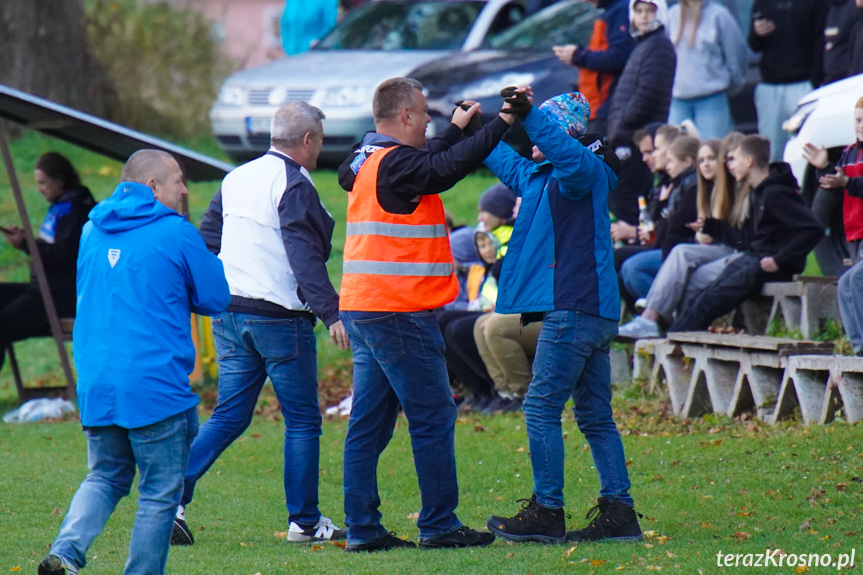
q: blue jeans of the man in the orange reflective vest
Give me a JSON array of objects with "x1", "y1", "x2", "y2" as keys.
[{"x1": 340, "y1": 311, "x2": 461, "y2": 545}]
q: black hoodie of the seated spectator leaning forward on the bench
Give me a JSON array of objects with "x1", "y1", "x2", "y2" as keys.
[{"x1": 704, "y1": 162, "x2": 824, "y2": 277}]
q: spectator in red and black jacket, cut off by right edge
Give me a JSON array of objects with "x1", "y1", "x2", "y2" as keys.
[{"x1": 803, "y1": 98, "x2": 863, "y2": 355}]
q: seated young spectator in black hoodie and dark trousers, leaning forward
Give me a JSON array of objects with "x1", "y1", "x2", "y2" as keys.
[{"x1": 668, "y1": 136, "x2": 824, "y2": 331}]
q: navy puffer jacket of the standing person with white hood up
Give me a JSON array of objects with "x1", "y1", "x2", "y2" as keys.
[{"x1": 608, "y1": 26, "x2": 677, "y2": 146}]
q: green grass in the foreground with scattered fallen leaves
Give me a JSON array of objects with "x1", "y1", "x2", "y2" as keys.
[{"x1": 0, "y1": 398, "x2": 863, "y2": 575}]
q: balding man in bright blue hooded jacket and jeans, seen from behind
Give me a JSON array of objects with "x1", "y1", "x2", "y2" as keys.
[{"x1": 38, "y1": 150, "x2": 230, "y2": 575}]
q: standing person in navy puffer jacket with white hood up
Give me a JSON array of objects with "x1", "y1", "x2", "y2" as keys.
[{"x1": 608, "y1": 0, "x2": 677, "y2": 234}]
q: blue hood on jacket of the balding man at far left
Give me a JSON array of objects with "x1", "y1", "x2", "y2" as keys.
[{"x1": 90, "y1": 182, "x2": 179, "y2": 234}]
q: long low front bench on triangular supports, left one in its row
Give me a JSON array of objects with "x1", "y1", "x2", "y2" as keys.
[{"x1": 633, "y1": 332, "x2": 833, "y2": 423}]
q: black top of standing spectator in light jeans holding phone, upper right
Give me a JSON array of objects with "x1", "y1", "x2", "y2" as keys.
[{"x1": 749, "y1": 0, "x2": 827, "y2": 86}]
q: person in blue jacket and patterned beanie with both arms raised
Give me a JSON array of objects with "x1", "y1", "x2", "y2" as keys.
[{"x1": 485, "y1": 86, "x2": 641, "y2": 543}]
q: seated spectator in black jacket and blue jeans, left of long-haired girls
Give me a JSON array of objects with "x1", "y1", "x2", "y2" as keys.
[{"x1": 620, "y1": 136, "x2": 699, "y2": 300}]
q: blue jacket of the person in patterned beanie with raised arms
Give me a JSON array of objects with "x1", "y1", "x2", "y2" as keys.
[{"x1": 485, "y1": 108, "x2": 620, "y2": 321}]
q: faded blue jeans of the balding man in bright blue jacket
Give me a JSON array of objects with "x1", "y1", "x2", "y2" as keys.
[{"x1": 51, "y1": 407, "x2": 198, "y2": 575}]
